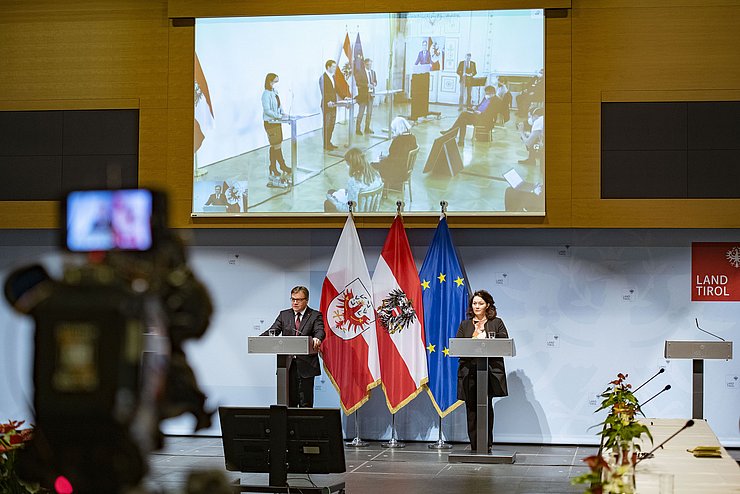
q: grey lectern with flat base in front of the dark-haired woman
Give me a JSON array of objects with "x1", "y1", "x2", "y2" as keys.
[{"x1": 448, "y1": 338, "x2": 516, "y2": 463}]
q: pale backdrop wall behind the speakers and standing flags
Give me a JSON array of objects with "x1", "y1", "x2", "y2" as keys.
[{"x1": 0, "y1": 229, "x2": 740, "y2": 446}]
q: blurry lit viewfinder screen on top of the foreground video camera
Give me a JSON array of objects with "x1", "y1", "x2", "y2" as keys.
[{"x1": 66, "y1": 189, "x2": 152, "y2": 252}]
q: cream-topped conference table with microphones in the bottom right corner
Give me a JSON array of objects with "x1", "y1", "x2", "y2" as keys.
[{"x1": 635, "y1": 419, "x2": 740, "y2": 494}]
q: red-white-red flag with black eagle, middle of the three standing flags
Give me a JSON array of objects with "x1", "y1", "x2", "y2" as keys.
[{"x1": 373, "y1": 215, "x2": 428, "y2": 413}]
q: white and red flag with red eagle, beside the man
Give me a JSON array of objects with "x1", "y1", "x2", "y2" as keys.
[{"x1": 321, "y1": 215, "x2": 380, "y2": 415}]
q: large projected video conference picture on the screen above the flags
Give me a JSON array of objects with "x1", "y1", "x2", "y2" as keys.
[{"x1": 193, "y1": 10, "x2": 545, "y2": 216}]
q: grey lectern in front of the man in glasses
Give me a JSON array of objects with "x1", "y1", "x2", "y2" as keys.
[{"x1": 247, "y1": 336, "x2": 316, "y2": 406}]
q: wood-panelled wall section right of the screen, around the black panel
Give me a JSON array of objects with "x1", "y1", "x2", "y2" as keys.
[{"x1": 571, "y1": 0, "x2": 740, "y2": 228}]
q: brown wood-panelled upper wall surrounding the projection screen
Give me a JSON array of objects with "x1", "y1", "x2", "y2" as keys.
[{"x1": 0, "y1": 0, "x2": 740, "y2": 228}]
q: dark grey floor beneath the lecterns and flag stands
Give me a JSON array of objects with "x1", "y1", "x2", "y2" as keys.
[{"x1": 146, "y1": 437, "x2": 596, "y2": 494}]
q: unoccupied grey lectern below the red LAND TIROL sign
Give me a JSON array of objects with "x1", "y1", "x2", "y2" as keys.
[{"x1": 664, "y1": 340, "x2": 732, "y2": 419}]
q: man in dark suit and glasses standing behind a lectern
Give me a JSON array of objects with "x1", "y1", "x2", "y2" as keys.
[{"x1": 262, "y1": 286, "x2": 326, "y2": 408}]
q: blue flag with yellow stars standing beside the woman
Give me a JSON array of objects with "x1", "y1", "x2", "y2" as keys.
[{"x1": 419, "y1": 217, "x2": 468, "y2": 417}]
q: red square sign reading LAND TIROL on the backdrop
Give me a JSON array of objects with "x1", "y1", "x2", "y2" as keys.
[{"x1": 691, "y1": 242, "x2": 740, "y2": 302}]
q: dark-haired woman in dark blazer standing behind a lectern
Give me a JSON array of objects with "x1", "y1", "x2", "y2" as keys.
[{"x1": 456, "y1": 290, "x2": 509, "y2": 451}]
